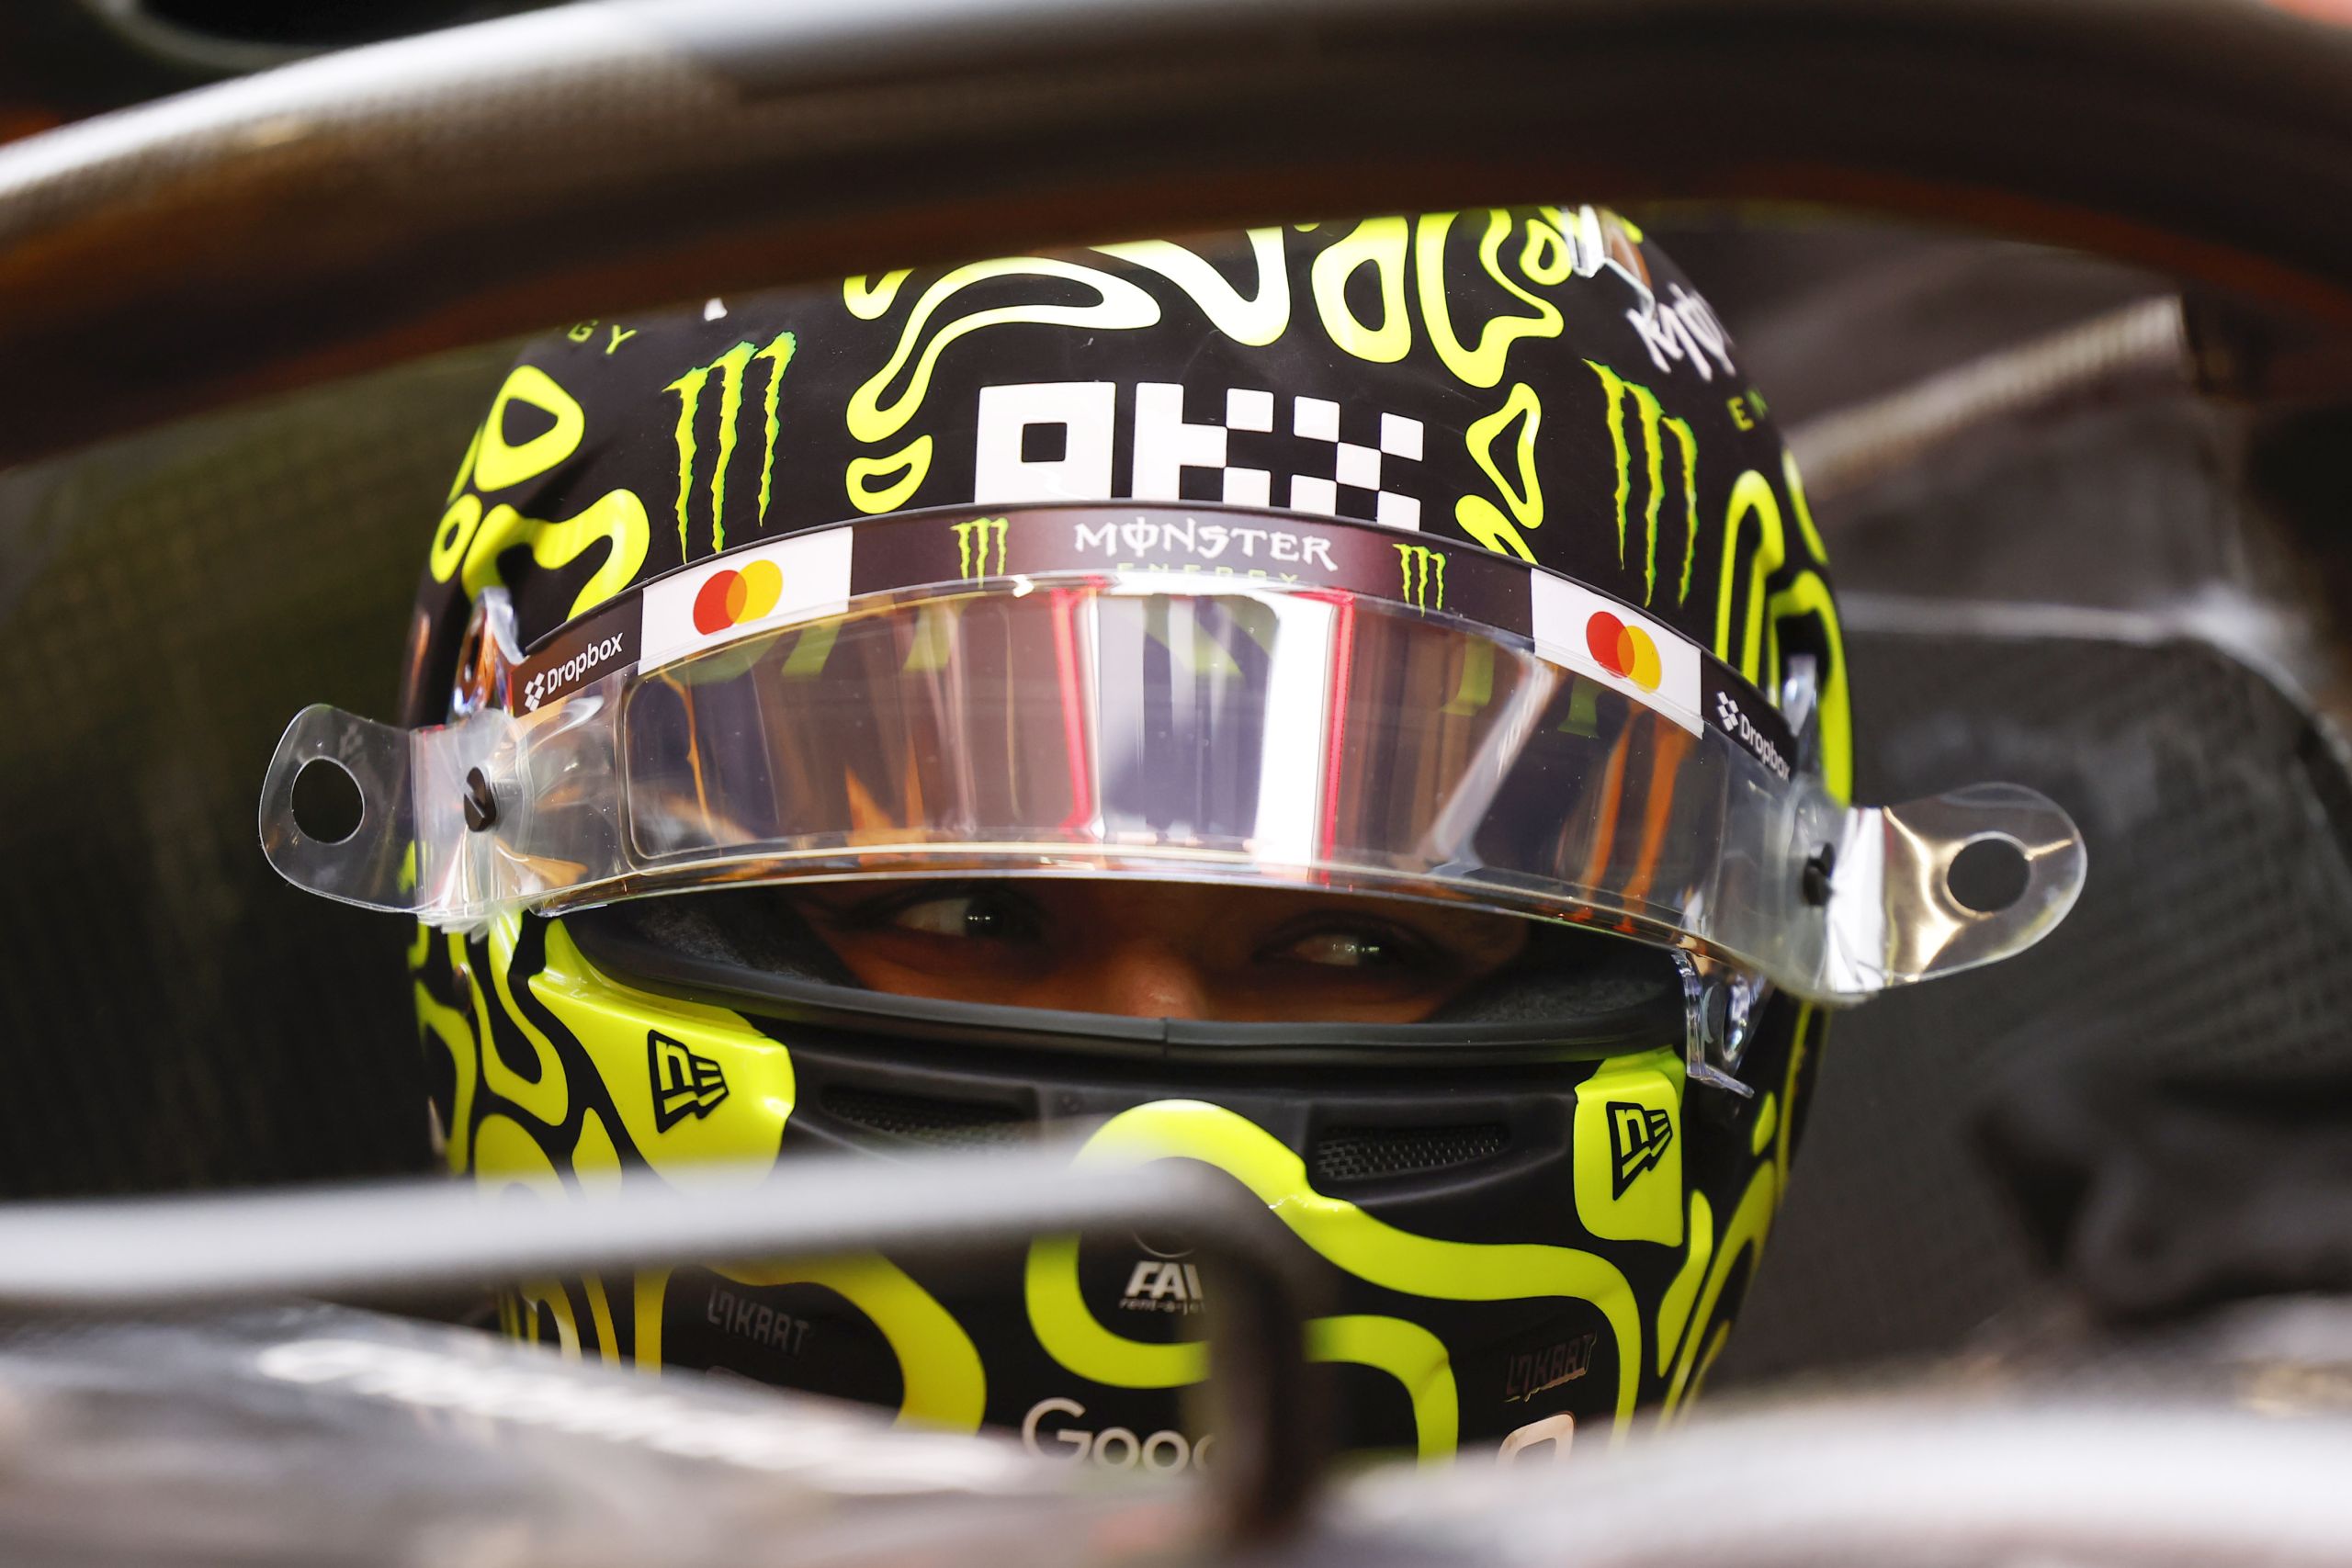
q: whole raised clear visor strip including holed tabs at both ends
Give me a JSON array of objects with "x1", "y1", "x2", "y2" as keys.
[{"x1": 264, "y1": 505, "x2": 2082, "y2": 999}]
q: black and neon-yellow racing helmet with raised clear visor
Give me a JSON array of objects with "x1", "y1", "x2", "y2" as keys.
[{"x1": 261, "y1": 207, "x2": 2084, "y2": 1470}]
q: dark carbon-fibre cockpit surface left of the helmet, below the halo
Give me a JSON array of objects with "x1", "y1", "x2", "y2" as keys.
[{"x1": 0, "y1": 350, "x2": 505, "y2": 1197}]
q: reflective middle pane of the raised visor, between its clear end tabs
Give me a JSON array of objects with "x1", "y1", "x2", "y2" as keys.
[{"x1": 618, "y1": 588, "x2": 1721, "y2": 917}]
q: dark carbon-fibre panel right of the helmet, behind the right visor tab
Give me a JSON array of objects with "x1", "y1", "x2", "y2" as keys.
[{"x1": 1713, "y1": 632, "x2": 2352, "y2": 1389}]
